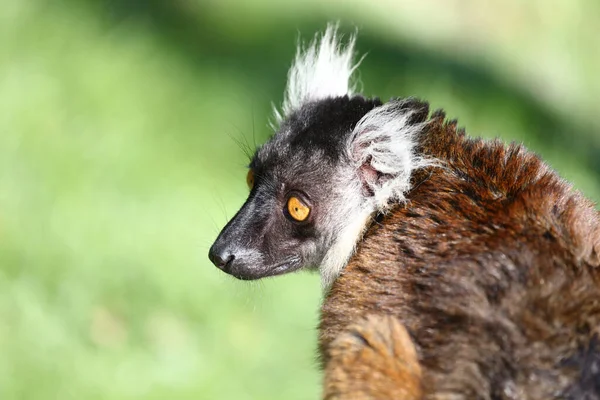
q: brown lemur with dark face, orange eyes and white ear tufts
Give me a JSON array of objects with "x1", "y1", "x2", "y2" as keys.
[{"x1": 209, "y1": 25, "x2": 600, "y2": 400}]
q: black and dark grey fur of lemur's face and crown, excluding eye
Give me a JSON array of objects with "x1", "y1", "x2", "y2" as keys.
[{"x1": 209, "y1": 96, "x2": 382, "y2": 279}]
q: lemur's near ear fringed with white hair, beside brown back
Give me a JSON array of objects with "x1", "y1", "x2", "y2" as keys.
[{"x1": 349, "y1": 99, "x2": 433, "y2": 210}]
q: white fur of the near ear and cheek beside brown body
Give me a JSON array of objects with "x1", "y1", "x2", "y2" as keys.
[{"x1": 320, "y1": 101, "x2": 437, "y2": 290}]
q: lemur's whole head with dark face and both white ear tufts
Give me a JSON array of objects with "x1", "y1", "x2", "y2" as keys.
[{"x1": 209, "y1": 26, "x2": 430, "y2": 287}]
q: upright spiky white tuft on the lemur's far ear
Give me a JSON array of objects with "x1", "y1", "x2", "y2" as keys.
[{"x1": 274, "y1": 24, "x2": 360, "y2": 124}]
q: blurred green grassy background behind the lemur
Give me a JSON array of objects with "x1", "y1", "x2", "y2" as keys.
[{"x1": 0, "y1": 0, "x2": 600, "y2": 400}]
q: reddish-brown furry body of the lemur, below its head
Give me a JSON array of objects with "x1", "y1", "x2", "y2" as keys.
[{"x1": 320, "y1": 106, "x2": 600, "y2": 399}]
